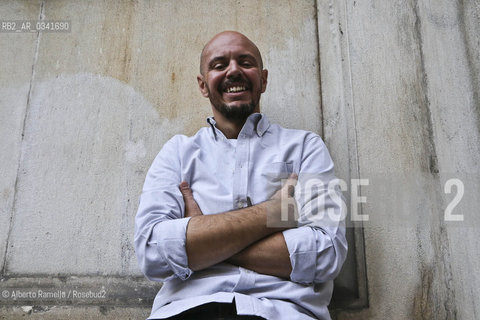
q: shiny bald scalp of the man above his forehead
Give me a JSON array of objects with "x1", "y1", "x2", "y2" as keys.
[{"x1": 200, "y1": 31, "x2": 263, "y2": 75}]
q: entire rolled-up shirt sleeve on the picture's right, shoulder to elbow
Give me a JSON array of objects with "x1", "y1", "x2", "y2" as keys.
[{"x1": 283, "y1": 135, "x2": 347, "y2": 284}]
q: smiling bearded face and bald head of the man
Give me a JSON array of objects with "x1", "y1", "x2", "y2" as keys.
[{"x1": 197, "y1": 31, "x2": 268, "y2": 121}]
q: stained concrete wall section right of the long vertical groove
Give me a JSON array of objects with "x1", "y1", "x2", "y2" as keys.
[{"x1": 318, "y1": 0, "x2": 480, "y2": 319}]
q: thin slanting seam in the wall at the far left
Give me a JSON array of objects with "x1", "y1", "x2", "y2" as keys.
[{"x1": 1, "y1": 1, "x2": 45, "y2": 277}]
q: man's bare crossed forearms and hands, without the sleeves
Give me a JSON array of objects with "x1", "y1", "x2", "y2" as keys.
[{"x1": 179, "y1": 175, "x2": 297, "y2": 279}]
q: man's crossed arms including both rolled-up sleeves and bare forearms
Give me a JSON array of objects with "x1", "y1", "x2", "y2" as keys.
[{"x1": 135, "y1": 137, "x2": 347, "y2": 284}]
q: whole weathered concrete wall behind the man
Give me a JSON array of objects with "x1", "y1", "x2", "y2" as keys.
[{"x1": 0, "y1": 0, "x2": 480, "y2": 319}]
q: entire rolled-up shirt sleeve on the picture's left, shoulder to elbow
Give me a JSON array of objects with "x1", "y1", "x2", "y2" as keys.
[{"x1": 135, "y1": 136, "x2": 192, "y2": 281}]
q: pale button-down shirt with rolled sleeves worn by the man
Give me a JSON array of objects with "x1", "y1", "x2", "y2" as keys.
[{"x1": 135, "y1": 113, "x2": 347, "y2": 320}]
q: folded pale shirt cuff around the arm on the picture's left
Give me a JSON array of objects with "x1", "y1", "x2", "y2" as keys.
[{"x1": 151, "y1": 218, "x2": 193, "y2": 280}]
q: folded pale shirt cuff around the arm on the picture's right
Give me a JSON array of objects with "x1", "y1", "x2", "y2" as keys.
[{"x1": 283, "y1": 227, "x2": 317, "y2": 284}]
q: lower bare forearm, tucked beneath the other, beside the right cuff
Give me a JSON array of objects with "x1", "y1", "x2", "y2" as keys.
[{"x1": 227, "y1": 232, "x2": 292, "y2": 279}]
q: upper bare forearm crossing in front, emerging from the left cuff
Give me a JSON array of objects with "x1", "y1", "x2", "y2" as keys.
[{"x1": 186, "y1": 201, "x2": 281, "y2": 270}]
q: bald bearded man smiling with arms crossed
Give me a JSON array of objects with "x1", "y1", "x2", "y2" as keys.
[{"x1": 135, "y1": 31, "x2": 347, "y2": 320}]
